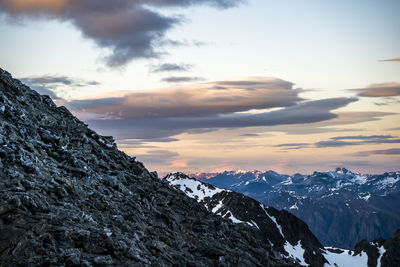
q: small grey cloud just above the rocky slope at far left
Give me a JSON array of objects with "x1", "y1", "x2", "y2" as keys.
[{"x1": 20, "y1": 75, "x2": 100, "y2": 100}]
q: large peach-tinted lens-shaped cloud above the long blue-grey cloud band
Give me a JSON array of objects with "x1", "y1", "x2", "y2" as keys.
[{"x1": 69, "y1": 78, "x2": 304, "y2": 119}]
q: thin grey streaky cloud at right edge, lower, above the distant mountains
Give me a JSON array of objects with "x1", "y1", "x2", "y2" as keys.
[{"x1": 315, "y1": 135, "x2": 400, "y2": 148}]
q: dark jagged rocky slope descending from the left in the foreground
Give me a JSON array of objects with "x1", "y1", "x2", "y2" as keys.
[{"x1": 0, "y1": 69, "x2": 297, "y2": 266}]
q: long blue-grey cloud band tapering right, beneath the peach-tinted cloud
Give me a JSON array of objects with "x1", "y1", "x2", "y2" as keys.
[{"x1": 79, "y1": 98, "x2": 356, "y2": 139}]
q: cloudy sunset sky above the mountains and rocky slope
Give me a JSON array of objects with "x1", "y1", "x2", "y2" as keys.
[{"x1": 0, "y1": 0, "x2": 400, "y2": 175}]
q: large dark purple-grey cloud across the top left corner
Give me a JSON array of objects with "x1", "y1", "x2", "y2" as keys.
[{"x1": 0, "y1": 0, "x2": 242, "y2": 67}]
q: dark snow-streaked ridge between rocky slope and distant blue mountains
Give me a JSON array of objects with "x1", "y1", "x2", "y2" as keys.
[{"x1": 165, "y1": 173, "x2": 400, "y2": 267}]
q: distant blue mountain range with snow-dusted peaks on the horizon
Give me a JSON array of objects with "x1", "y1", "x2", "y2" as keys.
[{"x1": 191, "y1": 168, "x2": 400, "y2": 249}]
